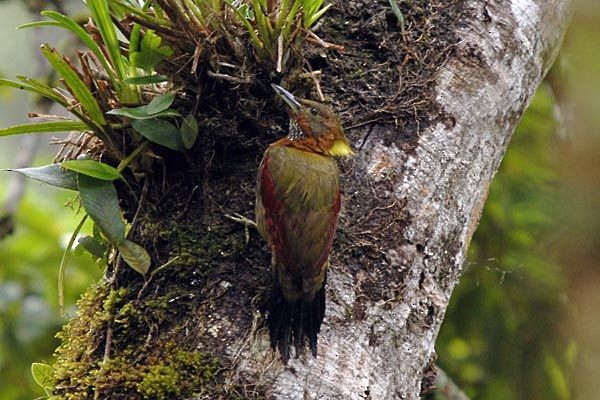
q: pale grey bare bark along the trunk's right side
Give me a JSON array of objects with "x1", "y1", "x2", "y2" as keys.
[{"x1": 230, "y1": 0, "x2": 569, "y2": 400}]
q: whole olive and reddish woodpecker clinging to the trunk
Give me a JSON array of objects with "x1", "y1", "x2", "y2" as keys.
[{"x1": 256, "y1": 85, "x2": 352, "y2": 362}]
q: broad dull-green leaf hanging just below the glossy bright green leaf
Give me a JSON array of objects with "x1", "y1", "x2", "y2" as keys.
[{"x1": 77, "y1": 174, "x2": 125, "y2": 245}]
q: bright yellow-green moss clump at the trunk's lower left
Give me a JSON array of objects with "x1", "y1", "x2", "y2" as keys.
[{"x1": 54, "y1": 285, "x2": 218, "y2": 400}]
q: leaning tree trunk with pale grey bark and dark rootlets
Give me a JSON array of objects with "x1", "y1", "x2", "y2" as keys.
[{"x1": 52, "y1": 0, "x2": 569, "y2": 400}]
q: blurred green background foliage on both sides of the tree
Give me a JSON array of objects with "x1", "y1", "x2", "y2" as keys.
[{"x1": 0, "y1": 1, "x2": 600, "y2": 400}]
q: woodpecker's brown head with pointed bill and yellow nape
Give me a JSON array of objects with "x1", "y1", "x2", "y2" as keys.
[{"x1": 271, "y1": 84, "x2": 354, "y2": 156}]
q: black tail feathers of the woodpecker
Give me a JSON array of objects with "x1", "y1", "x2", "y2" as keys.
[{"x1": 267, "y1": 280, "x2": 325, "y2": 363}]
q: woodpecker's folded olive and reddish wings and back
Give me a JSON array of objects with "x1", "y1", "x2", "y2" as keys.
[{"x1": 257, "y1": 147, "x2": 340, "y2": 291}]
